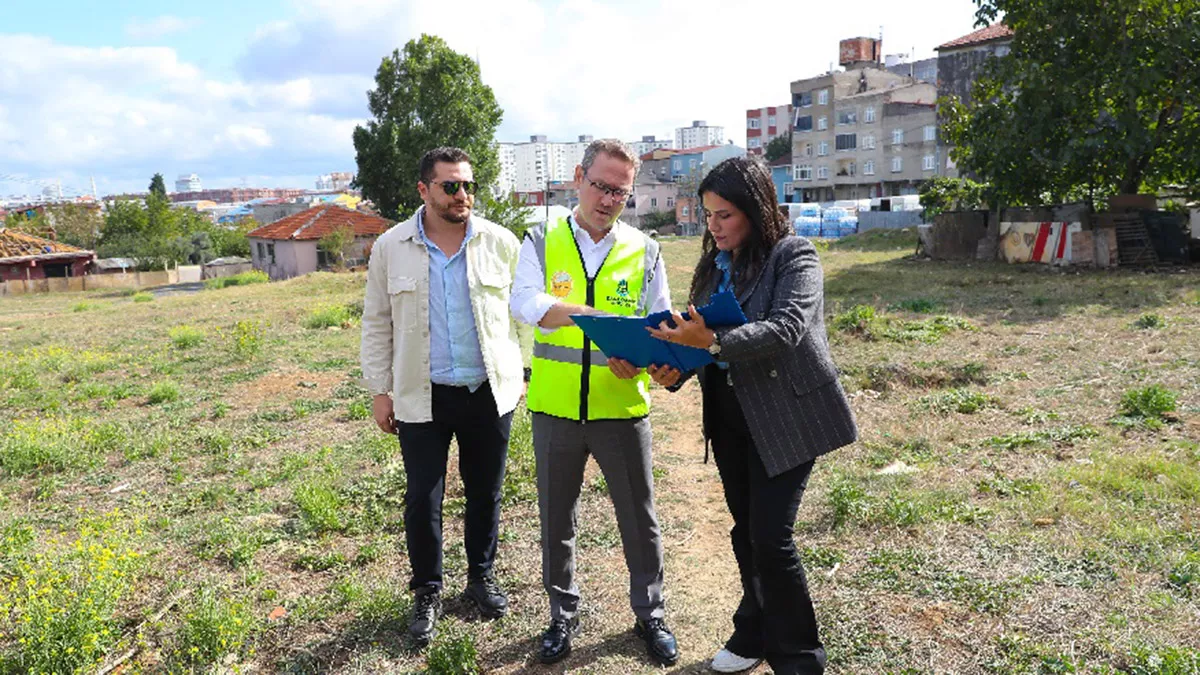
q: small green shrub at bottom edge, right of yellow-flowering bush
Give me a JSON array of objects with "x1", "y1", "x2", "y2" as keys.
[{"x1": 172, "y1": 589, "x2": 259, "y2": 671}]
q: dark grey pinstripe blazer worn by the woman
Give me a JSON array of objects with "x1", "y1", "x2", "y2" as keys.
[{"x1": 697, "y1": 237, "x2": 858, "y2": 477}]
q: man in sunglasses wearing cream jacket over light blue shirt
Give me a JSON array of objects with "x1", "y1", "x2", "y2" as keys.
[{"x1": 361, "y1": 148, "x2": 524, "y2": 647}]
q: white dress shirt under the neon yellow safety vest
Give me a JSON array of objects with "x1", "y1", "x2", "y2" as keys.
[{"x1": 509, "y1": 214, "x2": 671, "y2": 333}]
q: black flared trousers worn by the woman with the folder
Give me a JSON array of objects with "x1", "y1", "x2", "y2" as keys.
[{"x1": 704, "y1": 365, "x2": 826, "y2": 675}]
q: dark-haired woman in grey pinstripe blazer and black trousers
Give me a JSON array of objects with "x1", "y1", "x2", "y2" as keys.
[{"x1": 649, "y1": 157, "x2": 858, "y2": 675}]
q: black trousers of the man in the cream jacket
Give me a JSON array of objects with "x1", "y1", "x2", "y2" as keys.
[{"x1": 398, "y1": 382, "x2": 512, "y2": 591}]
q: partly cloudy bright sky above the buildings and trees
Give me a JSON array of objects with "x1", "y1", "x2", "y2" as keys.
[{"x1": 0, "y1": 0, "x2": 976, "y2": 199}]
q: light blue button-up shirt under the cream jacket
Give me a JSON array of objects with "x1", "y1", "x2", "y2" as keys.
[{"x1": 416, "y1": 209, "x2": 487, "y2": 392}]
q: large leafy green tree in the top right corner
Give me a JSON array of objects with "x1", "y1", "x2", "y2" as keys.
[{"x1": 941, "y1": 0, "x2": 1200, "y2": 204}]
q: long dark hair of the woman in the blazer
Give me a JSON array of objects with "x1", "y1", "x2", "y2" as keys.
[{"x1": 690, "y1": 157, "x2": 792, "y2": 303}]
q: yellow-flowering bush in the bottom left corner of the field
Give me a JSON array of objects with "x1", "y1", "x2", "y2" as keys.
[{"x1": 0, "y1": 512, "x2": 140, "y2": 673}]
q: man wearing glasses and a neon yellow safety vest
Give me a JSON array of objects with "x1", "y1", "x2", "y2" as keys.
[{"x1": 510, "y1": 139, "x2": 679, "y2": 665}]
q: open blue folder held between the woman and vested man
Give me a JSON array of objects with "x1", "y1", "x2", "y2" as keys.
[{"x1": 571, "y1": 292, "x2": 746, "y2": 372}]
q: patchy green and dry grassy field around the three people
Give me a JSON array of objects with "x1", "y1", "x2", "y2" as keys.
[{"x1": 0, "y1": 228, "x2": 1200, "y2": 675}]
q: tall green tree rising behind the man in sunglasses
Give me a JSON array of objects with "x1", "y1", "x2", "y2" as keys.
[{"x1": 354, "y1": 35, "x2": 504, "y2": 220}]
